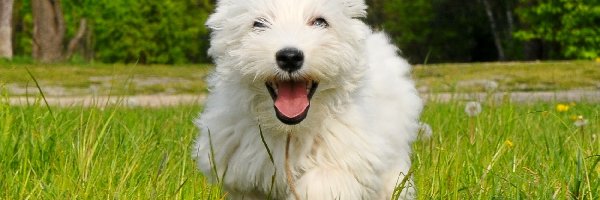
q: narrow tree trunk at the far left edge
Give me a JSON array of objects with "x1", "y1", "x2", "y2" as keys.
[{"x1": 0, "y1": 0, "x2": 14, "y2": 59}]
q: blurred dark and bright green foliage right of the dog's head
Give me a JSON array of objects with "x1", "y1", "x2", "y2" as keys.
[{"x1": 367, "y1": 0, "x2": 600, "y2": 63}]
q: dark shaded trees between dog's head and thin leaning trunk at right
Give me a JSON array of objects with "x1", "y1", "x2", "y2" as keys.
[{"x1": 369, "y1": 0, "x2": 498, "y2": 63}]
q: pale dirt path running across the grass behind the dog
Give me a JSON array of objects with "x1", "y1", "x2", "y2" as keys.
[{"x1": 9, "y1": 90, "x2": 600, "y2": 107}]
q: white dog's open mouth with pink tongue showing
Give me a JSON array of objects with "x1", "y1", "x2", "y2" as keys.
[{"x1": 265, "y1": 80, "x2": 319, "y2": 125}]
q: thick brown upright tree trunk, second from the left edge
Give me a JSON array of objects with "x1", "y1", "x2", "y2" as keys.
[{"x1": 31, "y1": 0, "x2": 65, "y2": 62}]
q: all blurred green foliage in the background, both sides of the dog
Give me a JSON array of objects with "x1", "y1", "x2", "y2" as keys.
[{"x1": 13, "y1": 0, "x2": 600, "y2": 64}]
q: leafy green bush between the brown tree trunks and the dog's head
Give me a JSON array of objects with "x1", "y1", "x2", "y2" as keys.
[{"x1": 84, "y1": 0, "x2": 212, "y2": 64}]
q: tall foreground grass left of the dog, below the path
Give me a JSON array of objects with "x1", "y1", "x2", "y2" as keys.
[{"x1": 0, "y1": 100, "x2": 222, "y2": 199}]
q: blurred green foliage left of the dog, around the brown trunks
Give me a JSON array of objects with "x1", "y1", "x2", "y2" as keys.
[{"x1": 15, "y1": 0, "x2": 212, "y2": 64}]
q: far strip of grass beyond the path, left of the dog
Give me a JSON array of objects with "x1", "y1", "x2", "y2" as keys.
[{"x1": 0, "y1": 64, "x2": 210, "y2": 96}]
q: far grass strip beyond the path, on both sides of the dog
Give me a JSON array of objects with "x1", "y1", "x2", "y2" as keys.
[{"x1": 0, "y1": 61, "x2": 600, "y2": 96}]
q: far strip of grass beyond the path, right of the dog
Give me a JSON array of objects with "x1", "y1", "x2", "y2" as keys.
[{"x1": 413, "y1": 61, "x2": 600, "y2": 92}]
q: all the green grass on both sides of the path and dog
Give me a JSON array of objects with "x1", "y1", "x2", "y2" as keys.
[{"x1": 0, "y1": 61, "x2": 600, "y2": 199}]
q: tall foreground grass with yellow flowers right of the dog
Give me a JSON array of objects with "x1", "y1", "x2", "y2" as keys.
[{"x1": 413, "y1": 102, "x2": 600, "y2": 199}]
